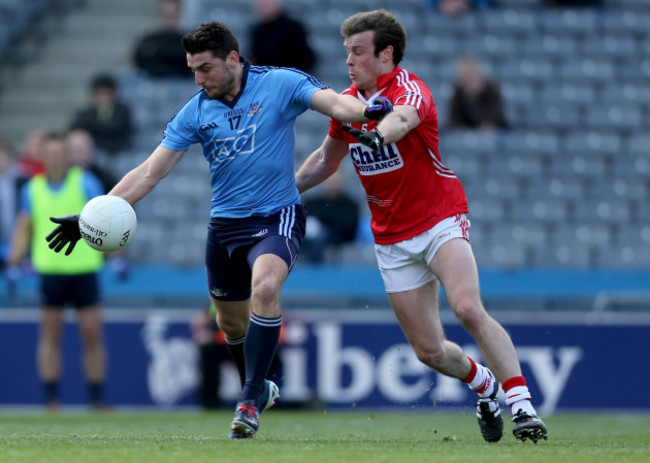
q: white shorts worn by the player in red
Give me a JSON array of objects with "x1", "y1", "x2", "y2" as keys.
[{"x1": 375, "y1": 214, "x2": 470, "y2": 293}]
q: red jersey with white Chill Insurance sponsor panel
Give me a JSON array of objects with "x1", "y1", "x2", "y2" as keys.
[{"x1": 329, "y1": 66, "x2": 468, "y2": 244}]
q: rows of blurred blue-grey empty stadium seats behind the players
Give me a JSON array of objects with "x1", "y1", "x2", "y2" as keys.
[{"x1": 116, "y1": 0, "x2": 650, "y2": 276}]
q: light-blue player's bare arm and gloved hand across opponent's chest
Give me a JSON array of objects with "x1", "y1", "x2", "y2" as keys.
[{"x1": 311, "y1": 88, "x2": 393, "y2": 123}]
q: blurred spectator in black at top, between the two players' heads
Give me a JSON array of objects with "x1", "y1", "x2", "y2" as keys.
[{"x1": 248, "y1": 0, "x2": 316, "y2": 73}]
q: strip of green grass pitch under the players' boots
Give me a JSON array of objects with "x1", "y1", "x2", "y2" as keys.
[{"x1": 0, "y1": 410, "x2": 650, "y2": 463}]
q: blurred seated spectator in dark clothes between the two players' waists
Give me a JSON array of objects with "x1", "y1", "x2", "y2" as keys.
[{"x1": 302, "y1": 170, "x2": 359, "y2": 262}]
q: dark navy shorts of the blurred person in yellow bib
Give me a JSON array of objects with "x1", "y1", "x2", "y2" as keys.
[{"x1": 41, "y1": 273, "x2": 100, "y2": 309}]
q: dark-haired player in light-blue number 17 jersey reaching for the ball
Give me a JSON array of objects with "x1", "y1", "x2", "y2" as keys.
[{"x1": 49, "y1": 22, "x2": 392, "y2": 438}]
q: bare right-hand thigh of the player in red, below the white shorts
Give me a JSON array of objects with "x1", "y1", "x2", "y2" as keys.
[{"x1": 429, "y1": 238, "x2": 480, "y2": 310}]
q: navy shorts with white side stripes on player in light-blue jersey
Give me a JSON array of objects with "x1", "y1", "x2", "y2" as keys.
[{"x1": 205, "y1": 204, "x2": 305, "y2": 301}]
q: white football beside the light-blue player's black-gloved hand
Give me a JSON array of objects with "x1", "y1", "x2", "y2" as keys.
[{"x1": 79, "y1": 195, "x2": 138, "y2": 252}]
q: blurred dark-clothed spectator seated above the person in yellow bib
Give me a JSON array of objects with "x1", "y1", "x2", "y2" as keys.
[{"x1": 70, "y1": 74, "x2": 133, "y2": 155}]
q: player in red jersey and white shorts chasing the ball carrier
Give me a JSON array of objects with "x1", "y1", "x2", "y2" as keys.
[{"x1": 296, "y1": 9, "x2": 547, "y2": 442}]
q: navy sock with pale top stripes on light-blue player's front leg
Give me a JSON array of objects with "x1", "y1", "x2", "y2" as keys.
[{"x1": 239, "y1": 313, "x2": 282, "y2": 402}]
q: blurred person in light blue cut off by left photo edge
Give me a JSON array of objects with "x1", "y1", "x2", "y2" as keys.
[{"x1": 0, "y1": 140, "x2": 20, "y2": 264}]
